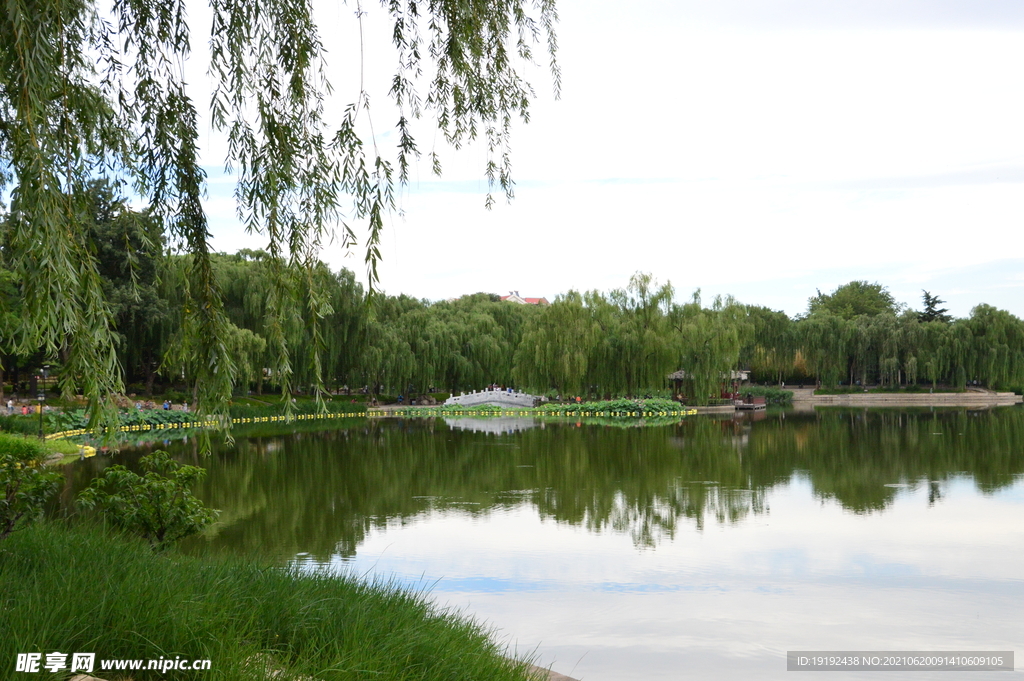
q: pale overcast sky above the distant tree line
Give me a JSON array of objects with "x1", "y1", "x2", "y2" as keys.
[{"x1": 197, "y1": 0, "x2": 1024, "y2": 316}]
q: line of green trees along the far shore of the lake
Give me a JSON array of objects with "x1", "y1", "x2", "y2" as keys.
[{"x1": 0, "y1": 182, "x2": 1024, "y2": 403}]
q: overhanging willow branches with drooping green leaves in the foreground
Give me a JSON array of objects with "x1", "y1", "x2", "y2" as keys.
[{"x1": 0, "y1": 0, "x2": 559, "y2": 419}]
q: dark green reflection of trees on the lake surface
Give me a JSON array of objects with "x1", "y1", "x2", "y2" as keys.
[{"x1": 65, "y1": 408, "x2": 1024, "y2": 559}]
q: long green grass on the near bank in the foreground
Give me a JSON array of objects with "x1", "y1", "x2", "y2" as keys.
[{"x1": 0, "y1": 522, "x2": 529, "y2": 681}]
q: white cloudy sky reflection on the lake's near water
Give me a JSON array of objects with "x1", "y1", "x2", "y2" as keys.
[{"x1": 321, "y1": 477, "x2": 1024, "y2": 681}]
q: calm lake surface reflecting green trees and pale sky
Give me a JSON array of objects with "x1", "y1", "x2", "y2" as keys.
[{"x1": 67, "y1": 408, "x2": 1024, "y2": 681}]
